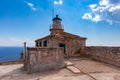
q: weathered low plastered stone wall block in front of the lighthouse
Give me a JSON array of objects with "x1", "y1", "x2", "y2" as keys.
[{"x1": 24, "y1": 47, "x2": 65, "y2": 73}]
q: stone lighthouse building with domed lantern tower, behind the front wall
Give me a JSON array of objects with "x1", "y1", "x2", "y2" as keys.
[{"x1": 35, "y1": 15, "x2": 86, "y2": 57}]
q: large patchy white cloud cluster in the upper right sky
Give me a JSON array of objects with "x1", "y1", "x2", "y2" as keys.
[{"x1": 82, "y1": 0, "x2": 120, "y2": 24}]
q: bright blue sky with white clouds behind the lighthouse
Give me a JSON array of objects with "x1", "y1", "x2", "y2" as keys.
[{"x1": 0, "y1": 0, "x2": 120, "y2": 46}]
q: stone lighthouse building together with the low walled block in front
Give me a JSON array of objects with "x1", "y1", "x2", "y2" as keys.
[{"x1": 24, "y1": 15, "x2": 86, "y2": 73}]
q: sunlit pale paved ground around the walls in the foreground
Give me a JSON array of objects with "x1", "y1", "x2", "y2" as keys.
[{"x1": 0, "y1": 58, "x2": 120, "y2": 80}]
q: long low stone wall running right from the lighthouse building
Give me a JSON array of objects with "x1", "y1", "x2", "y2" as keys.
[{"x1": 86, "y1": 46, "x2": 120, "y2": 66}]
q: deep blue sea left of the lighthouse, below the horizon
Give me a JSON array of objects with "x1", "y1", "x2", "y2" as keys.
[{"x1": 0, "y1": 47, "x2": 24, "y2": 62}]
